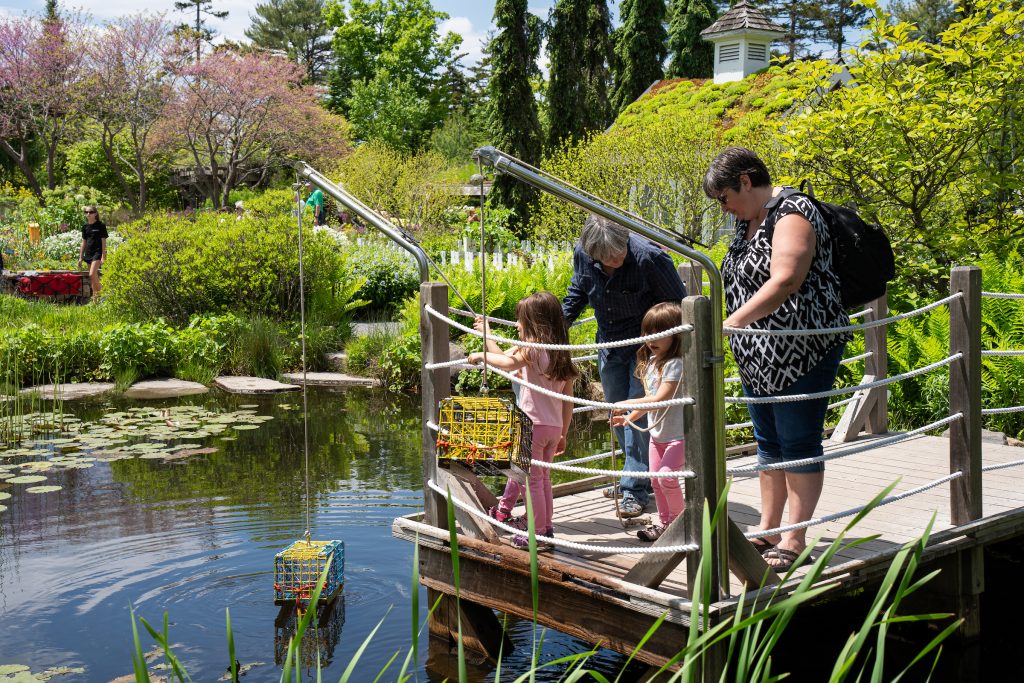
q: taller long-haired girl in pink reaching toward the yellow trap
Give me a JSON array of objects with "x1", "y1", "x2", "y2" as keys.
[{"x1": 468, "y1": 292, "x2": 579, "y2": 551}]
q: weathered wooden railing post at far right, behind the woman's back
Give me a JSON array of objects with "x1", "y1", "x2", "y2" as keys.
[{"x1": 949, "y1": 266, "x2": 982, "y2": 525}]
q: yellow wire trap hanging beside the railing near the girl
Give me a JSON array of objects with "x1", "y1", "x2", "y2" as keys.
[{"x1": 437, "y1": 396, "x2": 534, "y2": 474}]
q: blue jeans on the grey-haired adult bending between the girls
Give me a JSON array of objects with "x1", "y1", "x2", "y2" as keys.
[{"x1": 597, "y1": 348, "x2": 653, "y2": 506}]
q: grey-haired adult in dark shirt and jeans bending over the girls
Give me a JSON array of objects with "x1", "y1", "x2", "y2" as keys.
[{"x1": 562, "y1": 215, "x2": 686, "y2": 517}]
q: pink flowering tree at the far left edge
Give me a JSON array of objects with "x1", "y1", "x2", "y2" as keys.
[{"x1": 0, "y1": 16, "x2": 84, "y2": 199}]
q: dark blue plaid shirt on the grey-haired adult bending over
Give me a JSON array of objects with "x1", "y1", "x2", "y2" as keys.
[{"x1": 562, "y1": 234, "x2": 686, "y2": 359}]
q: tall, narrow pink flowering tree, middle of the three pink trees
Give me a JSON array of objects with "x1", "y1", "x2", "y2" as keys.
[{"x1": 84, "y1": 14, "x2": 184, "y2": 214}]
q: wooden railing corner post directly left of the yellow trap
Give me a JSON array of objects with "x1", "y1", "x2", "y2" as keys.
[{"x1": 420, "y1": 283, "x2": 452, "y2": 528}]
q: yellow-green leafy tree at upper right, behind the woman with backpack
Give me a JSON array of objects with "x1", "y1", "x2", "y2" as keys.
[{"x1": 779, "y1": 0, "x2": 1024, "y2": 300}]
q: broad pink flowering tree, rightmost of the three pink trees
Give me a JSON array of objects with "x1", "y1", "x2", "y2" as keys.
[{"x1": 158, "y1": 51, "x2": 348, "y2": 208}]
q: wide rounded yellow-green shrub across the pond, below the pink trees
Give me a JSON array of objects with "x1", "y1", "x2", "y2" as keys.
[{"x1": 104, "y1": 213, "x2": 361, "y2": 325}]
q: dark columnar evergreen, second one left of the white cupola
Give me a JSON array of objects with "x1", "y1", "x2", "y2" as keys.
[{"x1": 611, "y1": 0, "x2": 668, "y2": 114}]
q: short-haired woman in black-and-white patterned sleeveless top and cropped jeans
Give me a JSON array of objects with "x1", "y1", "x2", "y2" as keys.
[{"x1": 703, "y1": 147, "x2": 850, "y2": 571}]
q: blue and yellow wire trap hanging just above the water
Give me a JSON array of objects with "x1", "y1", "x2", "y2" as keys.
[{"x1": 273, "y1": 540, "x2": 345, "y2": 604}]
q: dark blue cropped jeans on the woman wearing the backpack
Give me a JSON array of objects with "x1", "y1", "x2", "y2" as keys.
[{"x1": 743, "y1": 344, "x2": 846, "y2": 474}]
